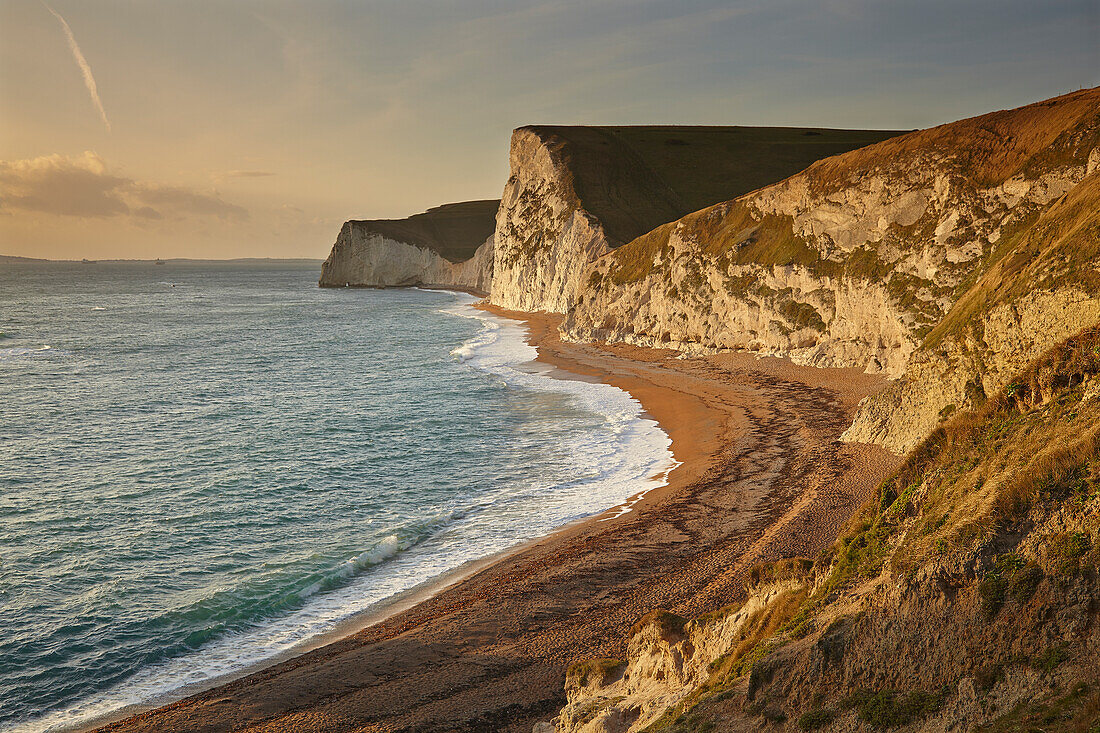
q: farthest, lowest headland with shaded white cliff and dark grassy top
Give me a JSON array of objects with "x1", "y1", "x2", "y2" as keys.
[{"x1": 320, "y1": 201, "x2": 498, "y2": 293}]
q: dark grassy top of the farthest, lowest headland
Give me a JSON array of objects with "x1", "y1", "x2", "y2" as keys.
[{"x1": 351, "y1": 200, "x2": 501, "y2": 262}]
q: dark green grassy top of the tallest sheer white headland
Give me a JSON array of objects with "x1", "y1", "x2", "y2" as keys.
[{"x1": 523, "y1": 125, "x2": 899, "y2": 243}]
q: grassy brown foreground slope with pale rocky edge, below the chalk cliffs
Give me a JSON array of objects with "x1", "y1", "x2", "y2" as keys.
[{"x1": 554, "y1": 328, "x2": 1100, "y2": 733}]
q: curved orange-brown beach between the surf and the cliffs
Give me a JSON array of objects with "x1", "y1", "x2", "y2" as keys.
[{"x1": 94, "y1": 308, "x2": 899, "y2": 733}]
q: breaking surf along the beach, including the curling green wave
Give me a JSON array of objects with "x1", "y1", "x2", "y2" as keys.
[{"x1": 15, "y1": 288, "x2": 673, "y2": 732}]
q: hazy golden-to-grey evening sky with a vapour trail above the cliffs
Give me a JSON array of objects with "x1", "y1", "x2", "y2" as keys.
[{"x1": 0, "y1": 0, "x2": 1100, "y2": 259}]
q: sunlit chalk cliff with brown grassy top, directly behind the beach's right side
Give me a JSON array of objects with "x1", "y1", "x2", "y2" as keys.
[{"x1": 562, "y1": 89, "x2": 1100, "y2": 451}]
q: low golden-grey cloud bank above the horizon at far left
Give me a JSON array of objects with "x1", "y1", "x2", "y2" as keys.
[{"x1": 0, "y1": 151, "x2": 249, "y2": 221}]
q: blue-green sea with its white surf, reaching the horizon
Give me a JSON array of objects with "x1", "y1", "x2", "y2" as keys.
[{"x1": 0, "y1": 261, "x2": 673, "y2": 732}]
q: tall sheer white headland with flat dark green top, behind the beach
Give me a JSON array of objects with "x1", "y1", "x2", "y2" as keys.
[{"x1": 491, "y1": 125, "x2": 895, "y2": 313}]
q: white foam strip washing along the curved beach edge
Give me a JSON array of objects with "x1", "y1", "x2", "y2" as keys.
[{"x1": 17, "y1": 288, "x2": 675, "y2": 733}]
